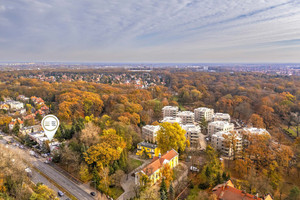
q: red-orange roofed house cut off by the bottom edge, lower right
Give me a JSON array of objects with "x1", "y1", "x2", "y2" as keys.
[{"x1": 212, "y1": 180, "x2": 273, "y2": 200}]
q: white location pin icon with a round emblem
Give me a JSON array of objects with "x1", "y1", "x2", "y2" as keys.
[{"x1": 42, "y1": 115, "x2": 59, "y2": 141}]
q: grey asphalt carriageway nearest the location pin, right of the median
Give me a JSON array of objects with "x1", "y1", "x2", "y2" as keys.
[{"x1": 0, "y1": 134, "x2": 94, "y2": 200}]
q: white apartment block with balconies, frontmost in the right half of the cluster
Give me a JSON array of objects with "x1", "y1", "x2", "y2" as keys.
[{"x1": 211, "y1": 131, "x2": 243, "y2": 156}]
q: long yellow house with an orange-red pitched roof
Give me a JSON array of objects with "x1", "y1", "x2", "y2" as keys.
[{"x1": 135, "y1": 149, "x2": 179, "y2": 185}]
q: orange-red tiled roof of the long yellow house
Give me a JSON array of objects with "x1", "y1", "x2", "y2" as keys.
[{"x1": 142, "y1": 149, "x2": 178, "y2": 176}]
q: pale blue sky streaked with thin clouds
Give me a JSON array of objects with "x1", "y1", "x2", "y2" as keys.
[{"x1": 0, "y1": 0, "x2": 300, "y2": 63}]
